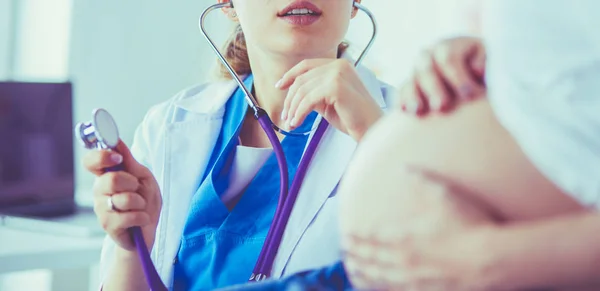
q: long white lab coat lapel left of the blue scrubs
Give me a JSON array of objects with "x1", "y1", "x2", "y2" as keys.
[{"x1": 156, "y1": 78, "x2": 237, "y2": 282}]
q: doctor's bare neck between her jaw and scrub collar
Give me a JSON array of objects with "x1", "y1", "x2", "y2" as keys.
[{"x1": 248, "y1": 47, "x2": 337, "y2": 121}]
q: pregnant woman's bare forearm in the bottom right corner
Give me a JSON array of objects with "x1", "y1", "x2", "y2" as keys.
[{"x1": 486, "y1": 212, "x2": 600, "y2": 290}]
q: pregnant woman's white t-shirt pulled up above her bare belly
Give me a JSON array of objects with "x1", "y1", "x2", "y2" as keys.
[{"x1": 483, "y1": 0, "x2": 600, "y2": 206}]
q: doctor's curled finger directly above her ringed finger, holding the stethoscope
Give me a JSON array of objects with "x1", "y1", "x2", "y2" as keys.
[{"x1": 93, "y1": 172, "x2": 140, "y2": 196}]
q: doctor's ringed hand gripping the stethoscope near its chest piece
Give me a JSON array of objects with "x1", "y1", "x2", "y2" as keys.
[{"x1": 83, "y1": 141, "x2": 162, "y2": 251}]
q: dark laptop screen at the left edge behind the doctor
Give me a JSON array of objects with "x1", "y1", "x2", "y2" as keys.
[{"x1": 0, "y1": 82, "x2": 75, "y2": 211}]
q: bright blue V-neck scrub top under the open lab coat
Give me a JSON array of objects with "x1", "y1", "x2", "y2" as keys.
[{"x1": 173, "y1": 76, "x2": 317, "y2": 291}]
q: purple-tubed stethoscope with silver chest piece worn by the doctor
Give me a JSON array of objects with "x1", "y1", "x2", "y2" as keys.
[{"x1": 75, "y1": 2, "x2": 377, "y2": 291}]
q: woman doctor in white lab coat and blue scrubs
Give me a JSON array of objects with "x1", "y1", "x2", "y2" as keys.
[{"x1": 84, "y1": 0, "x2": 488, "y2": 291}]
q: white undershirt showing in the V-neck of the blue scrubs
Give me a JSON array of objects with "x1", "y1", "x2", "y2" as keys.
[{"x1": 221, "y1": 146, "x2": 273, "y2": 209}]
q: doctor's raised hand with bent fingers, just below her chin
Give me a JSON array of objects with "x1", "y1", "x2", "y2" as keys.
[{"x1": 276, "y1": 59, "x2": 383, "y2": 141}]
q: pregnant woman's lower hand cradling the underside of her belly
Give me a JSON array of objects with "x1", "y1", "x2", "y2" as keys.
[{"x1": 343, "y1": 169, "x2": 495, "y2": 291}]
